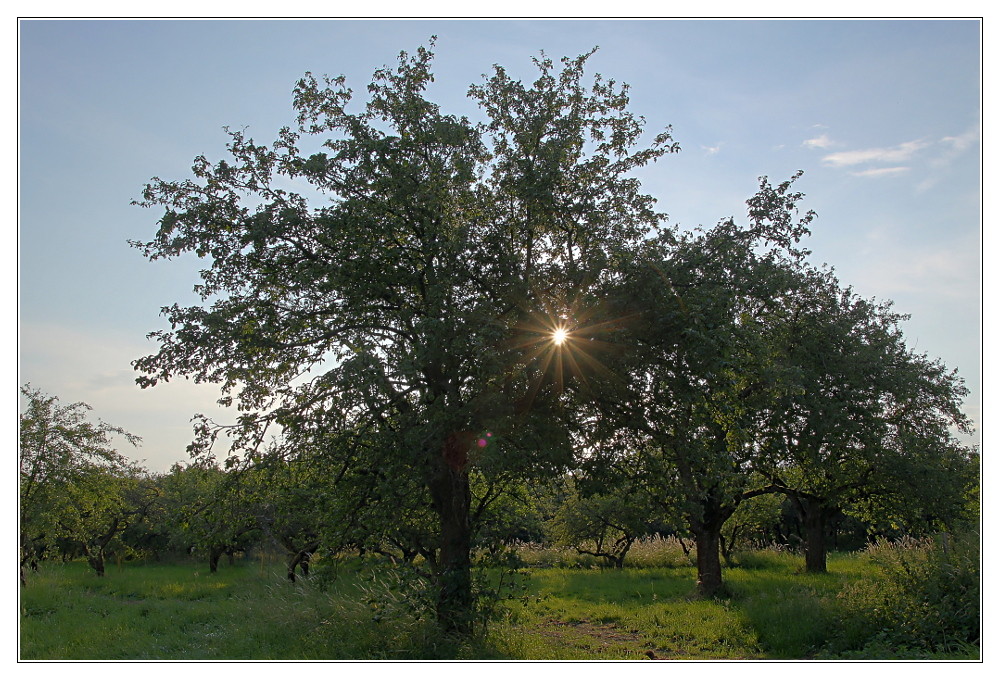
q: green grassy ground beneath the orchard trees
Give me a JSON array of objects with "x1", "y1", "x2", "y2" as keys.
[{"x1": 20, "y1": 553, "x2": 978, "y2": 660}]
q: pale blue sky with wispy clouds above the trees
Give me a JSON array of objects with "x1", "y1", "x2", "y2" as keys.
[{"x1": 18, "y1": 20, "x2": 982, "y2": 470}]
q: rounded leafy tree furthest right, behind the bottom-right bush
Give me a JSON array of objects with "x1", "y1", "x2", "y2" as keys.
[{"x1": 761, "y1": 271, "x2": 972, "y2": 572}]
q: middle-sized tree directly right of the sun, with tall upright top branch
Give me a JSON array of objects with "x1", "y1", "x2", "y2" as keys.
[{"x1": 595, "y1": 175, "x2": 813, "y2": 595}]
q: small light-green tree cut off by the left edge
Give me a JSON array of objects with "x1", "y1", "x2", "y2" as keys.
[{"x1": 18, "y1": 384, "x2": 142, "y2": 579}]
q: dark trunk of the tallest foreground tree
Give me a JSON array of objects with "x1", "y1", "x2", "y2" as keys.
[{"x1": 428, "y1": 432, "x2": 473, "y2": 635}]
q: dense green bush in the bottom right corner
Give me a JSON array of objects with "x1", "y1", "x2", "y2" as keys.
[{"x1": 833, "y1": 536, "x2": 980, "y2": 657}]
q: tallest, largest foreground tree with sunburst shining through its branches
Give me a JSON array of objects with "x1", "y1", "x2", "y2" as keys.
[{"x1": 135, "y1": 41, "x2": 676, "y2": 633}]
